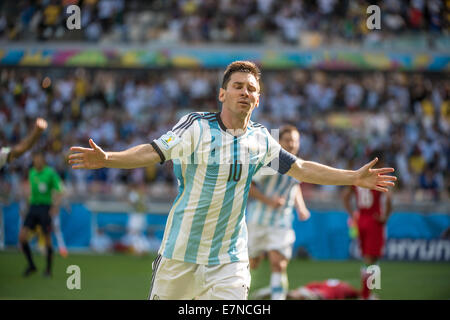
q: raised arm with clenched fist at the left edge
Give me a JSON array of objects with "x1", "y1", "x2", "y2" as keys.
[{"x1": 0, "y1": 118, "x2": 47, "y2": 169}]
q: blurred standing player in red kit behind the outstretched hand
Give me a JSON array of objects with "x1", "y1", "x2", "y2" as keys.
[{"x1": 342, "y1": 156, "x2": 392, "y2": 299}]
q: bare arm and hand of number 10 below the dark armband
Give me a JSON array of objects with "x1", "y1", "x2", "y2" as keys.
[{"x1": 287, "y1": 158, "x2": 397, "y2": 192}]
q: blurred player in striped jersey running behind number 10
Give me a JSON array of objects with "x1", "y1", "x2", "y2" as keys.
[{"x1": 247, "y1": 125, "x2": 310, "y2": 300}]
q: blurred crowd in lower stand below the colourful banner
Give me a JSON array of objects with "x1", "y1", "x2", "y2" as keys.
[{"x1": 0, "y1": 68, "x2": 450, "y2": 201}]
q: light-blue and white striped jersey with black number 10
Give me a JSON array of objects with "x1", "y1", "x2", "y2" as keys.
[{"x1": 152, "y1": 112, "x2": 281, "y2": 265}]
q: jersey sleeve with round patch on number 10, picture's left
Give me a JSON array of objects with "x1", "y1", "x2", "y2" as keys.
[{"x1": 151, "y1": 113, "x2": 201, "y2": 163}]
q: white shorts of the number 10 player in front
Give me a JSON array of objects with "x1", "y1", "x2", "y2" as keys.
[{"x1": 149, "y1": 255, "x2": 250, "y2": 300}]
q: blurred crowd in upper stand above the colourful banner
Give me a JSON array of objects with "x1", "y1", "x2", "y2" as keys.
[{"x1": 0, "y1": 0, "x2": 450, "y2": 47}]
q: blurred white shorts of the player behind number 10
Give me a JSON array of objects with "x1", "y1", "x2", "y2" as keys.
[{"x1": 247, "y1": 224, "x2": 295, "y2": 260}]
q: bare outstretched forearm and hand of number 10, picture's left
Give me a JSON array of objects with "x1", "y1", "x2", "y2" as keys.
[{"x1": 69, "y1": 139, "x2": 161, "y2": 169}]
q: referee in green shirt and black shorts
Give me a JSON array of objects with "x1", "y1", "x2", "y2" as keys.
[{"x1": 19, "y1": 152, "x2": 62, "y2": 277}]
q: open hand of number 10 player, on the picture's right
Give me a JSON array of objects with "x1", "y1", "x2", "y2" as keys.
[{"x1": 355, "y1": 158, "x2": 397, "y2": 192}]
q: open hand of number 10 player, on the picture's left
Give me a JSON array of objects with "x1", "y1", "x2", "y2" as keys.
[{"x1": 69, "y1": 139, "x2": 108, "y2": 169}]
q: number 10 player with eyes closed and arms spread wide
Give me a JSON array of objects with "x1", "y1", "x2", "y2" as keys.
[{"x1": 69, "y1": 61, "x2": 396, "y2": 299}]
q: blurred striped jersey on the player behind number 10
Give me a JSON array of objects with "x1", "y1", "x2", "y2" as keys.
[{"x1": 247, "y1": 173, "x2": 299, "y2": 229}]
